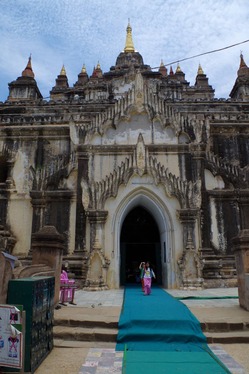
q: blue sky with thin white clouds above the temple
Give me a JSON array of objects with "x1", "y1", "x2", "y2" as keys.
[{"x1": 0, "y1": 0, "x2": 249, "y2": 101}]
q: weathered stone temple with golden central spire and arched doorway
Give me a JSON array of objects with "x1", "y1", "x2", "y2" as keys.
[{"x1": 0, "y1": 23, "x2": 249, "y2": 290}]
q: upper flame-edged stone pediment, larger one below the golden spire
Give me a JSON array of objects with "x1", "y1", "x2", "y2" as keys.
[{"x1": 77, "y1": 73, "x2": 209, "y2": 143}]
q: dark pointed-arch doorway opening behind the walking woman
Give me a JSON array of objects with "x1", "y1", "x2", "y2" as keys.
[{"x1": 120, "y1": 206, "x2": 162, "y2": 285}]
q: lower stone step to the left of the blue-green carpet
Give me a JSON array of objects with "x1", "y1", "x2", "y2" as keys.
[{"x1": 53, "y1": 326, "x2": 118, "y2": 342}]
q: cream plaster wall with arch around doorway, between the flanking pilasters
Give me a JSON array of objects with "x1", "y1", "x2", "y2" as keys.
[{"x1": 103, "y1": 176, "x2": 183, "y2": 288}]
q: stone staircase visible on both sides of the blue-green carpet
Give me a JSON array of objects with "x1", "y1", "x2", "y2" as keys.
[{"x1": 54, "y1": 307, "x2": 249, "y2": 348}]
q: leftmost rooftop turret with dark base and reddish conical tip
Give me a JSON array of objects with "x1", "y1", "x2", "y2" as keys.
[{"x1": 8, "y1": 56, "x2": 42, "y2": 101}]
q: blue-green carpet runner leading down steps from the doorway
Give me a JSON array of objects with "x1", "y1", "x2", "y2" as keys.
[{"x1": 116, "y1": 286, "x2": 230, "y2": 374}]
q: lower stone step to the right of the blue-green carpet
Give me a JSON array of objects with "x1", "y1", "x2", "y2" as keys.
[{"x1": 205, "y1": 331, "x2": 249, "y2": 344}]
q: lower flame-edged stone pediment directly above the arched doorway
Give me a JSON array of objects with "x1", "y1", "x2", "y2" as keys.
[{"x1": 82, "y1": 134, "x2": 201, "y2": 210}]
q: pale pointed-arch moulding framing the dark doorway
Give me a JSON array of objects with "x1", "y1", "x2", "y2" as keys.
[{"x1": 112, "y1": 189, "x2": 176, "y2": 288}]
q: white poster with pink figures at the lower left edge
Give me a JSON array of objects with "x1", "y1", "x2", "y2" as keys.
[{"x1": 0, "y1": 304, "x2": 23, "y2": 369}]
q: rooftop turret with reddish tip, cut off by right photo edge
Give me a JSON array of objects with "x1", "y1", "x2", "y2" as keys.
[{"x1": 230, "y1": 53, "x2": 249, "y2": 101}]
